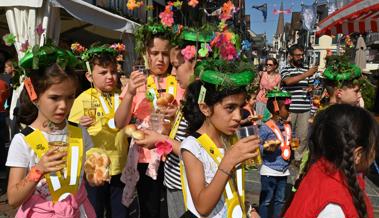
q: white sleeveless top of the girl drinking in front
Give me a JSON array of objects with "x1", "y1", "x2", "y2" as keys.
[{"x1": 180, "y1": 136, "x2": 227, "y2": 218}]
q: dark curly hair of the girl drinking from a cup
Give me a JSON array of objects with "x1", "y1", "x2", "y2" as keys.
[{"x1": 182, "y1": 80, "x2": 246, "y2": 134}]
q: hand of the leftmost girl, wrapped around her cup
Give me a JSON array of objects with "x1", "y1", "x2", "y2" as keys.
[{"x1": 36, "y1": 147, "x2": 67, "y2": 174}]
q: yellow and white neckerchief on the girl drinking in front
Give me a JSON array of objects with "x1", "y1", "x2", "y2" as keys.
[{"x1": 180, "y1": 134, "x2": 246, "y2": 218}]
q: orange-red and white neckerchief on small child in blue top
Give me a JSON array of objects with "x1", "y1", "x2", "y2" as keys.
[{"x1": 266, "y1": 120, "x2": 292, "y2": 160}]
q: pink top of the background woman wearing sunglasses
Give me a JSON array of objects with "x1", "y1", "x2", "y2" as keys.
[{"x1": 257, "y1": 71, "x2": 280, "y2": 104}]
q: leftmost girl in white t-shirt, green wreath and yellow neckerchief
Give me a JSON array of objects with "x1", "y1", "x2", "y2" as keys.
[{"x1": 6, "y1": 45, "x2": 96, "y2": 218}]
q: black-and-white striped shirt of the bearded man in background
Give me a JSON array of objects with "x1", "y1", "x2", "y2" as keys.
[{"x1": 280, "y1": 65, "x2": 313, "y2": 113}]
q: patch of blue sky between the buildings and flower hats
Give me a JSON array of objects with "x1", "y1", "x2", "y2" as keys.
[{"x1": 245, "y1": 0, "x2": 314, "y2": 43}]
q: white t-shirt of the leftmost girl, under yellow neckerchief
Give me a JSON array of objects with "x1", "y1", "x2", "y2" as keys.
[{"x1": 5, "y1": 123, "x2": 93, "y2": 200}]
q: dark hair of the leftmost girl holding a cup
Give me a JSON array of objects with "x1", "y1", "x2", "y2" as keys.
[{"x1": 17, "y1": 63, "x2": 78, "y2": 125}]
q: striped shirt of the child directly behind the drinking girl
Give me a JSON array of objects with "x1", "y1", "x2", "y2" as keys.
[{"x1": 164, "y1": 118, "x2": 188, "y2": 190}]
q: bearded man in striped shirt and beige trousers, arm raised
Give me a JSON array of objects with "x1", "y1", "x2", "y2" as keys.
[{"x1": 280, "y1": 45, "x2": 318, "y2": 164}]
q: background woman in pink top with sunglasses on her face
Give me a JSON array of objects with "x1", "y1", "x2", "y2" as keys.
[{"x1": 255, "y1": 58, "x2": 280, "y2": 115}]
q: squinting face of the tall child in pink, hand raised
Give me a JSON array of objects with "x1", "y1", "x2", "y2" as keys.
[{"x1": 147, "y1": 38, "x2": 170, "y2": 75}]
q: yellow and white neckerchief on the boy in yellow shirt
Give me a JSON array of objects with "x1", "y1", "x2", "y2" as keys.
[{"x1": 87, "y1": 88, "x2": 120, "y2": 131}]
